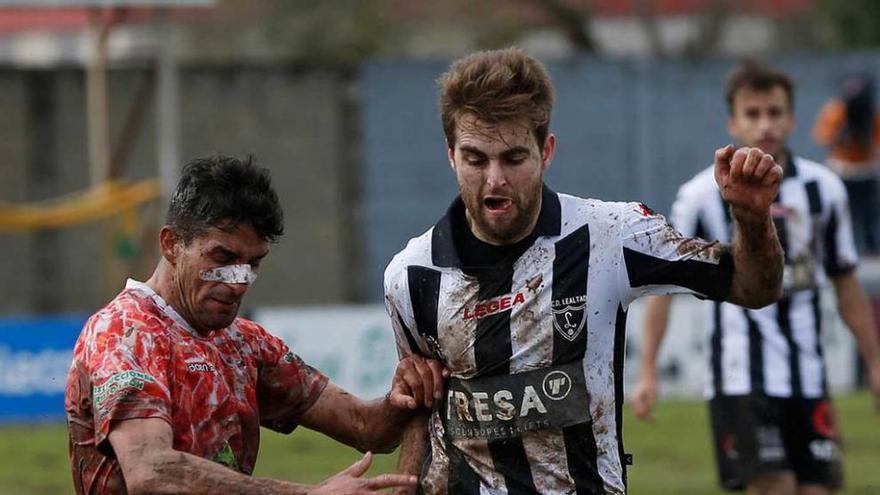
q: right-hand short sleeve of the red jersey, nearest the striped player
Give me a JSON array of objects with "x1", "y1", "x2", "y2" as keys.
[{"x1": 251, "y1": 328, "x2": 329, "y2": 433}]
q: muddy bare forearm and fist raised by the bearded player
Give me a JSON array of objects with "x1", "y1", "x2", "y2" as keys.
[{"x1": 715, "y1": 145, "x2": 783, "y2": 308}]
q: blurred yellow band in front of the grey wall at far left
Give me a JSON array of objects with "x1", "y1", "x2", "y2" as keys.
[{"x1": 0, "y1": 179, "x2": 161, "y2": 232}]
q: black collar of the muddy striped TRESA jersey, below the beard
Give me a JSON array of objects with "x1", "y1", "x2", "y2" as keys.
[{"x1": 431, "y1": 184, "x2": 562, "y2": 268}]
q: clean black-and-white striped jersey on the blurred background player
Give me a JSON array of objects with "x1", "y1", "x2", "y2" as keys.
[{"x1": 670, "y1": 157, "x2": 857, "y2": 398}]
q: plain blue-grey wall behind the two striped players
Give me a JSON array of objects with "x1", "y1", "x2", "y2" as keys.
[{"x1": 362, "y1": 53, "x2": 880, "y2": 300}]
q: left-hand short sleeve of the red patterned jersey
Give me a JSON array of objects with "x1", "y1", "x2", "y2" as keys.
[{"x1": 84, "y1": 312, "x2": 172, "y2": 447}]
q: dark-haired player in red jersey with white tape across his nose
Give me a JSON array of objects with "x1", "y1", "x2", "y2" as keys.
[{"x1": 65, "y1": 157, "x2": 442, "y2": 495}]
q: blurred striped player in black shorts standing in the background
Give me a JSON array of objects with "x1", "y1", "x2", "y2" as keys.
[{"x1": 633, "y1": 62, "x2": 880, "y2": 495}]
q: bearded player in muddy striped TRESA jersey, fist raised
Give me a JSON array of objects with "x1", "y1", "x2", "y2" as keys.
[{"x1": 385, "y1": 48, "x2": 782, "y2": 495}]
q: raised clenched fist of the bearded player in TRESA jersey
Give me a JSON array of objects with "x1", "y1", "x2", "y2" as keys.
[{"x1": 715, "y1": 145, "x2": 782, "y2": 220}]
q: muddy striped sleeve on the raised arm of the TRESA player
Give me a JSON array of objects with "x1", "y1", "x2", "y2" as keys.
[{"x1": 619, "y1": 203, "x2": 733, "y2": 305}]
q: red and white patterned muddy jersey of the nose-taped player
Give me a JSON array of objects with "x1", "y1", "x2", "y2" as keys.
[{"x1": 65, "y1": 280, "x2": 328, "y2": 495}]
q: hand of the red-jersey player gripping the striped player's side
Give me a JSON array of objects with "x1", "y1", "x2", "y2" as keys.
[{"x1": 388, "y1": 354, "x2": 449, "y2": 409}]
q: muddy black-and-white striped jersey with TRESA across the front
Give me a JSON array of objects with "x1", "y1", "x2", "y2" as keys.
[{"x1": 385, "y1": 187, "x2": 733, "y2": 495}]
